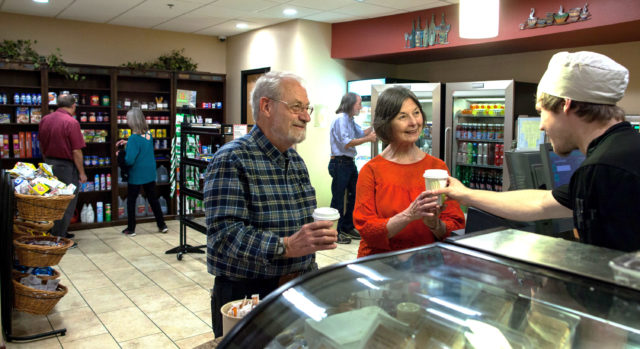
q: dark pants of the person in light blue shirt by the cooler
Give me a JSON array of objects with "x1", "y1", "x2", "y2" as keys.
[{"x1": 329, "y1": 156, "x2": 358, "y2": 232}]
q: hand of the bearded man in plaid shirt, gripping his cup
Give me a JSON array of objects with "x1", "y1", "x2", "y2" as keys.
[{"x1": 285, "y1": 221, "x2": 338, "y2": 257}]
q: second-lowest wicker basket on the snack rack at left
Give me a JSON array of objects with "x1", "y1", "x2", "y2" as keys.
[{"x1": 13, "y1": 236, "x2": 73, "y2": 267}]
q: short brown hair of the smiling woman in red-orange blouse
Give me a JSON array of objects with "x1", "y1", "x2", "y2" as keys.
[{"x1": 373, "y1": 86, "x2": 426, "y2": 144}]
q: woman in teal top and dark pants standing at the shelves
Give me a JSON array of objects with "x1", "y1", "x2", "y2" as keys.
[{"x1": 116, "y1": 107, "x2": 168, "y2": 236}]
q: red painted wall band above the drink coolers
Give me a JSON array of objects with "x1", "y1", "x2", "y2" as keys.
[{"x1": 331, "y1": 0, "x2": 640, "y2": 61}]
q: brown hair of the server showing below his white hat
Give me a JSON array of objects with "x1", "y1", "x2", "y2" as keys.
[{"x1": 538, "y1": 92, "x2": 625, "y2": 122}]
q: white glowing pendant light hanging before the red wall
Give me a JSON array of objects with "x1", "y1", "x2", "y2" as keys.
[{"x1": 459, "y1": 0, "x2": 500, "y2": 39}]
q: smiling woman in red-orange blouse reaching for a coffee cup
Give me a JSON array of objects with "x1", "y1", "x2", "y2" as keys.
[{"x1": 353, "y1": 87, "x2": 465, "y2": 257}]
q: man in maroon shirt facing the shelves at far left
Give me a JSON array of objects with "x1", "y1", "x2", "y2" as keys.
[{"x1": 38, "y1": 94, "x2": 87, "y2": 241}]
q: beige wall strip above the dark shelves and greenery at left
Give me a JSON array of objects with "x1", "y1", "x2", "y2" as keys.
[{"x1": 0, "y1": 12, "x2": 226, "y2": 74}]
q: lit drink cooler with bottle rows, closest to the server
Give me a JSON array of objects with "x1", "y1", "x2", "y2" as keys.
[{"x1": 444, "y1": 80, "x2": 538, "y2": 191}]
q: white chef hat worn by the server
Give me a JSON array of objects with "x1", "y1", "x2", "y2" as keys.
[{"x1": 538, "y1": 51, "x2": 629, "y2": 105}]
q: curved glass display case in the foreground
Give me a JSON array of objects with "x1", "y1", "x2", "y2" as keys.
[{"x1": 218, "y1": 230, "x2": 640, "y2": 348}]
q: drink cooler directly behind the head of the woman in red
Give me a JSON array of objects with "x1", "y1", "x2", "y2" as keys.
[{"x1": 371, "y1": 83, "x2": 444, "y2": 159}]
